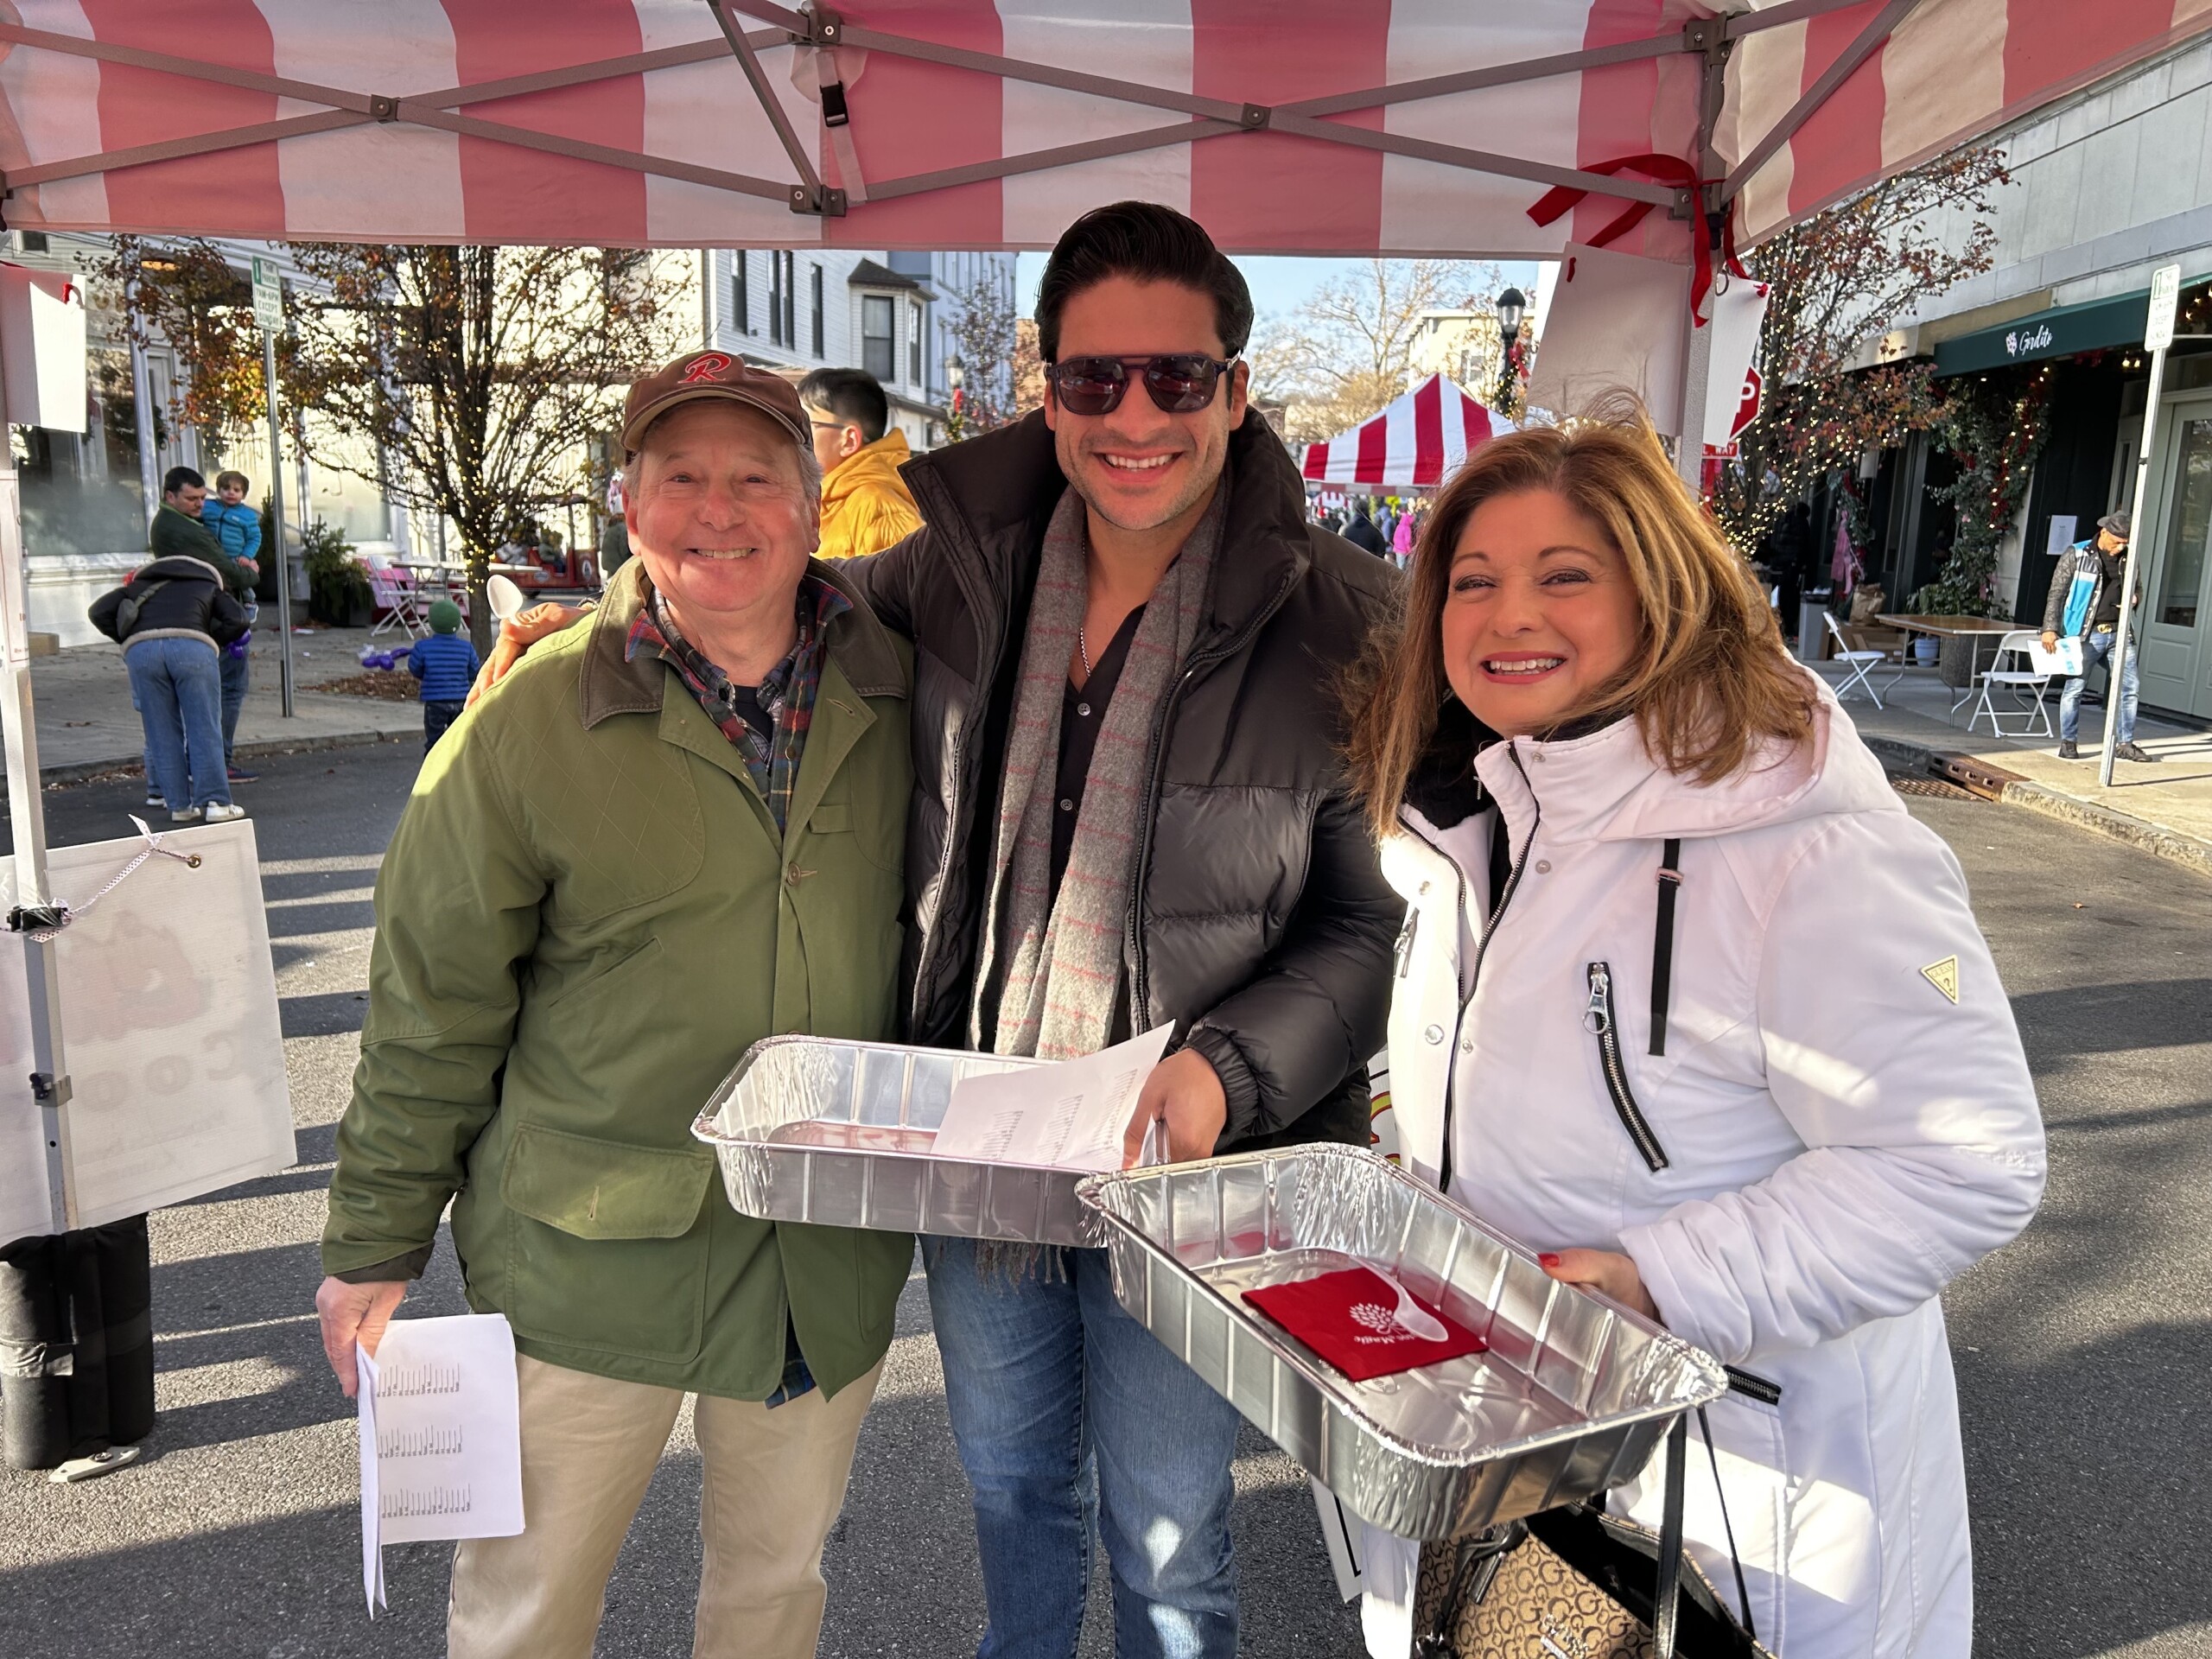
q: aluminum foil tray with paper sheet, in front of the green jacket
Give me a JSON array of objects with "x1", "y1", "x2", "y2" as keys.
[{"x1": 692, "y1": 1038, "x2": 1102, "y2": 1245}]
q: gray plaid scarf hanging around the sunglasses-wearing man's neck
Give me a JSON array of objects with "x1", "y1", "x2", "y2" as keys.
[{"x1": 969, "y1": 478, "x2": 1230, "y2": 1059}]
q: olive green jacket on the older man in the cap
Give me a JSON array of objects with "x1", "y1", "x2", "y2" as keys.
[{"x1": 323, "y1": 562, "x2": 913, "y2": 1400}]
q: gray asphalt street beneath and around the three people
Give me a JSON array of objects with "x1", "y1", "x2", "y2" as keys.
[{"x1": 0, "y1": 746, "x2": 2212, "y2": 1659}]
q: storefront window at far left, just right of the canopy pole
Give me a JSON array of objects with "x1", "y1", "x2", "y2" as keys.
[{"x1": 13, "y1": 345, "x2": 159, "y2": 557}]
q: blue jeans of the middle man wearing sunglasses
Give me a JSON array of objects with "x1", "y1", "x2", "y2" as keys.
[{"x1": 923, "y1": 1239, "x2": 1236, "y2": 1659}]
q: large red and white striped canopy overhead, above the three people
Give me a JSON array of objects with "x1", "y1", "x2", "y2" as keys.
[{"x1": 0, "y1": 0, "x2": 2185, "y2": 259}]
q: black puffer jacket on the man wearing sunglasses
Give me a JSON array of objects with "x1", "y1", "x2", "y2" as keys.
[{"x1": 842, "y1": 416, "x2": 1405, "y2": 1150}]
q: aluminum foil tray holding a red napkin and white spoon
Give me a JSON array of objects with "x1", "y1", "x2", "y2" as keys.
[{"x1": 1082, "y1": 1146, "x2": 1727, "y2": 1540}]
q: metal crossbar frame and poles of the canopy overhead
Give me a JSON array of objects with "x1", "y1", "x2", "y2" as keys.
[{"x1": 0, "y1": 0, "x2": 1955, "y2": 1232}]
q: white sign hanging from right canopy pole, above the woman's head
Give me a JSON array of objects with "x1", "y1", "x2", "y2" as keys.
[{"x1": 1529, "y1": 244, "x2": 1681, "y2": 434}]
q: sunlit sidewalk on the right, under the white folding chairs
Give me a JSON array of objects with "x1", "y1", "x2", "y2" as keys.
[{"x1": 1818, "y1": 664, "x2": 2212, "y2": 876}]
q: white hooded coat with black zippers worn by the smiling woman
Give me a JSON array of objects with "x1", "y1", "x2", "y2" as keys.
[{"x1": 1365, "y1": 688, "x2": 2044, "y2": 1659}]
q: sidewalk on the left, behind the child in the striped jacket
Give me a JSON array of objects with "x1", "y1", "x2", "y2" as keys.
[{"x1": 0, "y1": 617, "x2": 423, "y2": 797}]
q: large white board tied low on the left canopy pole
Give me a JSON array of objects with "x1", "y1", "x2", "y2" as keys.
[{"x1": 0, "y1": 818, "x2": 296, "y2": 1239}]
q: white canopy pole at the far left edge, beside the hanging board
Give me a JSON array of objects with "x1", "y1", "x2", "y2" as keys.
[{"x1": 0, "y1": 318, "x2": 78, "y2": 1232}]
